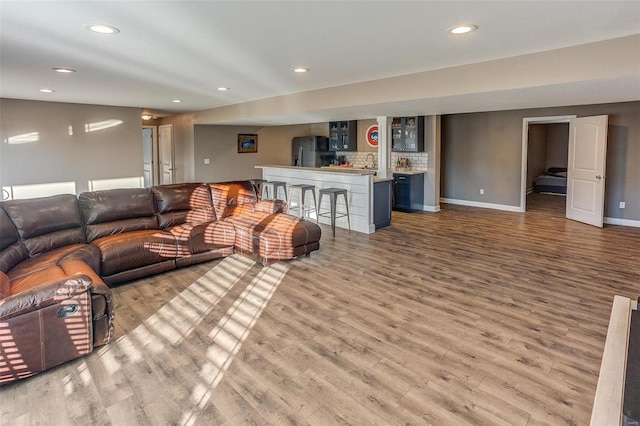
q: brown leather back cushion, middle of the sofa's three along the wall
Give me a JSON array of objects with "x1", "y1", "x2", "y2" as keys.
[{"x1": 78, "y1": 188, "x2": 158, "y2": 242}]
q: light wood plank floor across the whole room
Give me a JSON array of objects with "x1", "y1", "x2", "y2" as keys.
[{"x1": 0, "y1": 196, "x2": 640, "y2": 425}]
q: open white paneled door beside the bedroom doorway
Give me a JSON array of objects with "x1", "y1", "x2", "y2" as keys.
[{"x1": 567, "y1": 115, "x2": 609, "y2": 228}]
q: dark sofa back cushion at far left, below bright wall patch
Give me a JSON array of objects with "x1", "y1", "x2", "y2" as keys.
[{"x1": 2, "y1": 194, "x2": 86, "y2": 256}]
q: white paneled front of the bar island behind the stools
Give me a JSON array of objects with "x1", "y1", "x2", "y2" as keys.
[{"x1": 256, "y1": 166, "x2": 378, "y2": 234}]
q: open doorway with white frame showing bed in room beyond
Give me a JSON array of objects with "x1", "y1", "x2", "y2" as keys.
[{"x1": 520, "y1": 116, "x2": 575, "y2": 215}]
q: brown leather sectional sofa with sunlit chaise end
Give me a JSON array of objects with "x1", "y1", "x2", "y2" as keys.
[{"x1": 0, "y1": 181, "x2": 321, "y2": 385}]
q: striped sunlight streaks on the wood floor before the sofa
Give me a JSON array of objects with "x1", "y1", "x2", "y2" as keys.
[{"x1": 62, "y1": 255, "x2": 289, "y2": 425}]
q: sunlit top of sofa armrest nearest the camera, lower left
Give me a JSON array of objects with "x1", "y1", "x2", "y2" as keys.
[{"x1": 0, "y1": 274, "x2": 92, "y2": 320}]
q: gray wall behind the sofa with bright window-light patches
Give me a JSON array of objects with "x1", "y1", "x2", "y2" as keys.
[{"x1": 0, "y1": 99, "x2": 142, "y2": 193}]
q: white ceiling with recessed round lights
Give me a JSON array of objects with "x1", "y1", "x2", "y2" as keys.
[{"x1": 0, "y1": 0, "x2": 640, "y2": 124}]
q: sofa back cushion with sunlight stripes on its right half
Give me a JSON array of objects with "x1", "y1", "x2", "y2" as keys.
[{"x1": 151, "y1": 183, "x2": 216, "y2": 229}]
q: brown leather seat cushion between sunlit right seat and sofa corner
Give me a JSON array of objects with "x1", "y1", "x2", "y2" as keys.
[{"x1": 91, "y1": 230, "x2": 177, "y2": 277}]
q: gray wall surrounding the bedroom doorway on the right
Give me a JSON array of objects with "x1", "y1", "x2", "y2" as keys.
[{"x1": 441, "y1": 102, "x2": 640, "y2": 220}]
